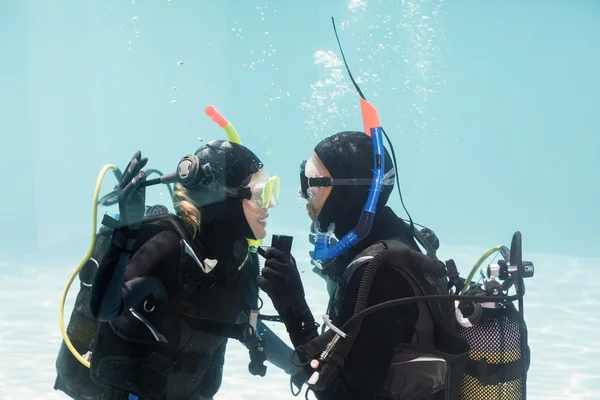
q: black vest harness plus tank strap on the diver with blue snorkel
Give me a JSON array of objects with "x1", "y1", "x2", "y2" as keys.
[{"x1": 296, "y1": 236, "x2": 523, "y2": 400}]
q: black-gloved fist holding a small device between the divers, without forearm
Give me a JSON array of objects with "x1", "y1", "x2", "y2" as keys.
[{"x1": 256, "y1": 247, "x2": 304, "y2": 314}]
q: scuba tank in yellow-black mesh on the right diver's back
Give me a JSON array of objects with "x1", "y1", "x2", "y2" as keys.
[{"x1": 455, "y1": 233, "x2": 533, "y2": 400}]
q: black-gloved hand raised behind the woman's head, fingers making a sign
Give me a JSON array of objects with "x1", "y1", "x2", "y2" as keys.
[{"x1": 117, "y1": 151, "x2": 148, "y2": 229}]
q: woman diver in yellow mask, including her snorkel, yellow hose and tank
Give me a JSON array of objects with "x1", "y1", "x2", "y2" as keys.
[{"x1": 54, "y1": 106, "x2": 300, "y2": 400}]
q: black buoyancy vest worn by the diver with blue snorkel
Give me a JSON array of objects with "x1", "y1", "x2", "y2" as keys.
[{"x1": 298, "y1": 240, "x2": 469, "y2": 400}]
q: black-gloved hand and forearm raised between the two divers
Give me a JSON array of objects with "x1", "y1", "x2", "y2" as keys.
[{"x1": 256, "y1": 247, "x2": 318, "y2": 346}]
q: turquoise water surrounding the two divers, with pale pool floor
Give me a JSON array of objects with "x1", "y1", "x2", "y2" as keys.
[{"x1": 0, "y1": 0, "x2": 600, "y2": 399}]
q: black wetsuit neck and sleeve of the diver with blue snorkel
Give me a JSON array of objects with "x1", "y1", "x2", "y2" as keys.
[{"x1": 291, "y1": 207, "x2": 420, "y2": 400}]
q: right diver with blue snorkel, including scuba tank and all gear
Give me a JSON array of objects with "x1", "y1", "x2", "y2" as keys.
[{"x1": 257, "y1": 18, "x2": 533, "y2": 400}]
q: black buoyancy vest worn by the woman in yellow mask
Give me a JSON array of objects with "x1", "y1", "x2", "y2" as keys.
[{"x1": 90, "y1": 216, "x2": 252, "y2": 399}]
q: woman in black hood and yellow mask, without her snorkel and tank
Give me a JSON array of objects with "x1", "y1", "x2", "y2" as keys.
[{"x1": 90, "y1": 141, "x2": 279, "y2": 400}]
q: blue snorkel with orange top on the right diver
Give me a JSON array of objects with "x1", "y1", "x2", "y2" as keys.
[{"x1": 313, "y1": 126, "x2": 385, "y2": 261}]
